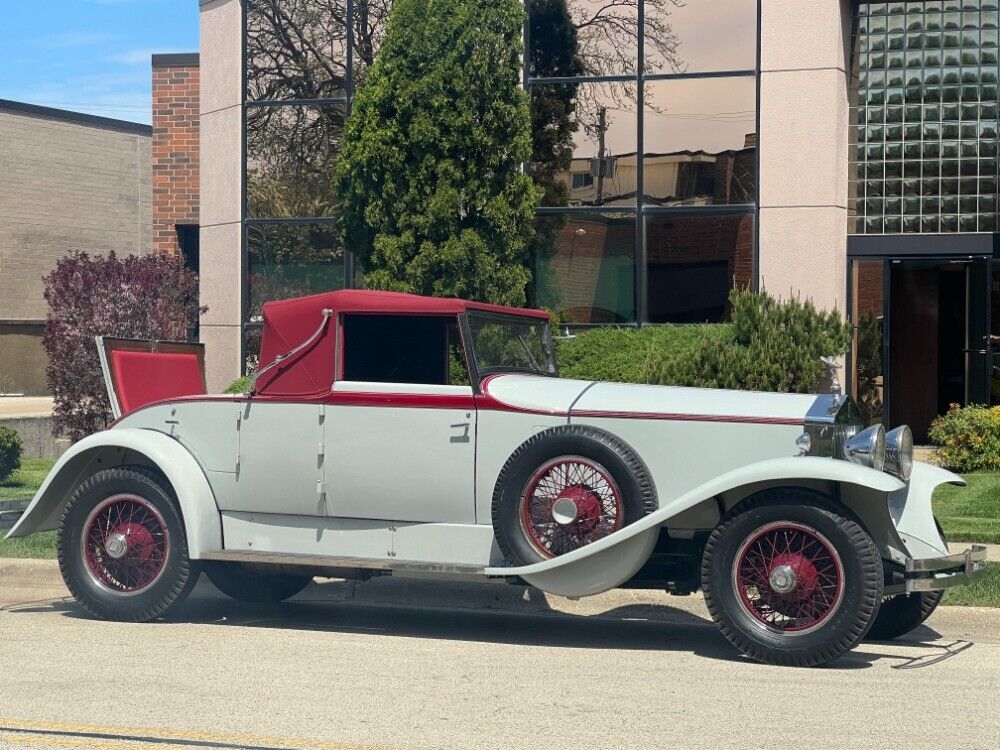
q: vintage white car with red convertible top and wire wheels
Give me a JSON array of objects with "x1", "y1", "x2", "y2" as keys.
[{"x1": 10, "y1": 290, "x2": 985, "y2": 665}]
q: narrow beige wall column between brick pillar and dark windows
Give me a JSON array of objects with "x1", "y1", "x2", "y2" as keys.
[{"x1": 200, "y1": 0, "x2": 243, "y2": 391}]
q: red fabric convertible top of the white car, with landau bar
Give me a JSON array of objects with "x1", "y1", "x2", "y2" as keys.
[{"x1": 256, "y1": 289, "x2": 549, "y2": 398}]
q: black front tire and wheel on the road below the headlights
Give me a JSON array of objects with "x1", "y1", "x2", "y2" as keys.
[{"x1": 701, "y1": 489, "x2": 883, "y2": 667}]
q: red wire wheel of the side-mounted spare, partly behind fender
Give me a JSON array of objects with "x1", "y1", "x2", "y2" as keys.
[{"x1": 519, "y1": 456, "x2": 624, "y2": 558}]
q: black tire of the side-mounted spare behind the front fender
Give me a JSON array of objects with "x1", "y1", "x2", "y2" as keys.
[{"x1": 493, "y1": 425, "x2": 657, "y2": 566}]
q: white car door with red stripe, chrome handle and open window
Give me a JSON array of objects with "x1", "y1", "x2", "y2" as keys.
[{"x1": 324, "y1": 315, "x2": 476, "y2": 523}]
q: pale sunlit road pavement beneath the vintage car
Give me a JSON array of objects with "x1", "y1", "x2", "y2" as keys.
[{"x1": 0, "y1": 561, "x2": 1000, "y2": 750}]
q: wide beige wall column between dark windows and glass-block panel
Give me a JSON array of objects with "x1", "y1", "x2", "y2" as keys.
[{"x1": 759, "y1": 0, "x2": 851, "y2": 313}]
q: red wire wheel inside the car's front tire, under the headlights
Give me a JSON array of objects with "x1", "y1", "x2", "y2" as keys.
[{"x1": 733, "y1": 522, "x2": 844, "y2": 635}]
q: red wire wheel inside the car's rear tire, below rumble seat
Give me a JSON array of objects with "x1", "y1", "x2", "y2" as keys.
[{"x1": 81, "y1": 495, "x2": 170, "y2": 596}]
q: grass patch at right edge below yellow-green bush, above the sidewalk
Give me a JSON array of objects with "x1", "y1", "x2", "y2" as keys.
[{"x1": 934, "y1": 473, "x2": 1000, "y2": 544}]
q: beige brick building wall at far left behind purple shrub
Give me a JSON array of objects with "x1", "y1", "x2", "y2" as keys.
[{"x1": 0, "y1": 106, "x2": 152, "y2": 395}]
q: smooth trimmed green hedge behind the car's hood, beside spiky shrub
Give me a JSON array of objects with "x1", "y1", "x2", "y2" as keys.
[{"x1": 556, "y1": 325, "x2": 733, "y2": 383}]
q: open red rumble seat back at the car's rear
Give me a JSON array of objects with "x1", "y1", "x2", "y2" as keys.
[{"x1": 97, "y1": 338, "x2": 206, "y2": 418}]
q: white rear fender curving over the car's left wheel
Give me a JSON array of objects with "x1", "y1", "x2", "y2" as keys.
[{"x1": 7, "y1": 428, "x2": 222, "y2": 559}]
